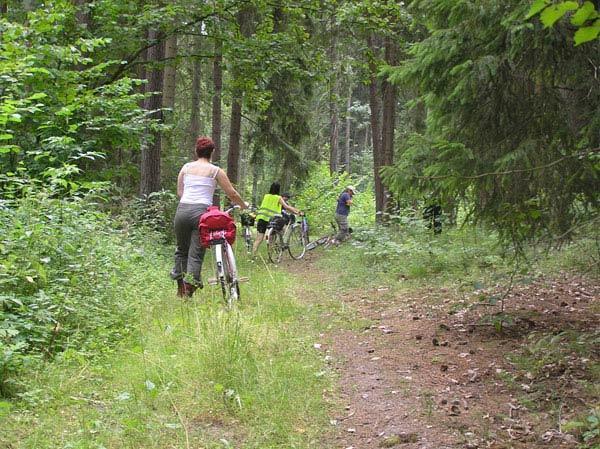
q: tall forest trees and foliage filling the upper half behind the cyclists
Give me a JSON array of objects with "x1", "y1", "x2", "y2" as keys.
[{"x1": 0, "y1": 0, "x2": 600, "y2": 241}]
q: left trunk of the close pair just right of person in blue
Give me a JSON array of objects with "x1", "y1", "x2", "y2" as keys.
[{"x1": 368, "y1": 34, "x2": 385, "y2": 222}]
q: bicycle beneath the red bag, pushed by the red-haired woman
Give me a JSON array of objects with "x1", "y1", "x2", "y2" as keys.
[{"x1": 209, "y1": 206, "x2": 240, "y2": 308}]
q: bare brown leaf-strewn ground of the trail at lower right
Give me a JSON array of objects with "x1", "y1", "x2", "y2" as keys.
[{"x1": 294, "y1": 254, "x2": 600, "y2": 449}]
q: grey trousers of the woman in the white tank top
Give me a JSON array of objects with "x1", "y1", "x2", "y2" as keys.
[{"x1": 171, "y1": 203, "x2": 208, "y2": 286}]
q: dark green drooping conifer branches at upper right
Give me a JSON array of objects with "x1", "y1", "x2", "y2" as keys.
[{"x1": 384, "y1": 0, "x2": 600, "y2": 245}]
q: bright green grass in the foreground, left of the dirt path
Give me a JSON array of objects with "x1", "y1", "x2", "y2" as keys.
[{"x1": 0, "y1": 245, "x2": 332, "y2": 449}]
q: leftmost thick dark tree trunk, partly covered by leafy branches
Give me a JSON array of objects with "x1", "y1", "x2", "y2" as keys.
[{"x1": 140, "y1": 30, "x2": 164, "y2": 195}]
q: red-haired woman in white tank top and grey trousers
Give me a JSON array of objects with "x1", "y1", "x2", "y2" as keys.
[{"x1": 171, "y1": 137, "x2": 247, "y2": 297}]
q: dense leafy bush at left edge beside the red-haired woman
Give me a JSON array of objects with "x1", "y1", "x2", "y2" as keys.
[{"x1": 0, "y1": 192, "x2": 169, "y2": 395}]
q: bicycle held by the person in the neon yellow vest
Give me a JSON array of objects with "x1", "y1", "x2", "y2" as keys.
[{"x1": 265, "y1": 214, "x2": 308, "y2": 264}]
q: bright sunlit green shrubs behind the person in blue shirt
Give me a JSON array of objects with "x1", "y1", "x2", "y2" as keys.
[{"x1": 292, "y1": 163, "x2": 375, "y2": 231}]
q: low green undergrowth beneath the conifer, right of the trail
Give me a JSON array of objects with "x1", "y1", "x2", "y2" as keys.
[{"x1": 322, "y1": 222, "x2": 600, "y2": 292}]
